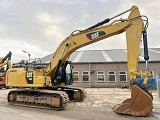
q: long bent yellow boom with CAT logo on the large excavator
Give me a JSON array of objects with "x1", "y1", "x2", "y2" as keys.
[{"x1": 46, "y1": 21, "x2": 131, "y2": 75}]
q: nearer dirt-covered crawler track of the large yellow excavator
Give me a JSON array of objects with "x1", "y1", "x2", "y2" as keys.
[{"x1": 8, "y1": 89, "x2": 69, "y2": 110}]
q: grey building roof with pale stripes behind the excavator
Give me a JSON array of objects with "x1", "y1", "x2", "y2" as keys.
[{"x1": 41, "y1": 48, "x2": 160, "y2": 63}]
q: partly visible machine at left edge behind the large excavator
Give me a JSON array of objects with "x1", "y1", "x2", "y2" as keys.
[{"x1": 0, "y1": 51, "x2": 12, "y2": 89}]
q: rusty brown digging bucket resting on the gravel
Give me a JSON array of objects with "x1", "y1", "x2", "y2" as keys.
[{"x1": 113, "y1": 85, "x2": 153, "y2": 116}]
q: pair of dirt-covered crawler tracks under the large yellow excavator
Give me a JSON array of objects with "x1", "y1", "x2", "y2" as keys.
[{"x1": 8, "y1": 87, "x2": 86, "y2": 110}]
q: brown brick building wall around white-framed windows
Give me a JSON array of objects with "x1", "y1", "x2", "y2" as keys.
[{"x1": 73, "y1": 63, "x2": 160, "y2": 87}]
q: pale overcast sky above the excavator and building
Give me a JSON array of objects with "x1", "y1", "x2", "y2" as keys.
[{"x1": 0, "y1": 0, "x2": 160, "y2": 62}]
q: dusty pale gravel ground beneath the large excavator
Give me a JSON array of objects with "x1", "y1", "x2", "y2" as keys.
[{"x1": 0, "y1": 88, "x2": 160, "y2": 120}]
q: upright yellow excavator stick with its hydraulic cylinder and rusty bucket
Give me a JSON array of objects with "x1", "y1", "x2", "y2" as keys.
[{"x1": 113, "y1": 9, "x2": 153, "y2": 116}]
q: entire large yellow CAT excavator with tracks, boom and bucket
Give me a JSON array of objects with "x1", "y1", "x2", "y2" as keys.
[{"x1": 6, "y1": 6, "x2": 153, "y2": 116}]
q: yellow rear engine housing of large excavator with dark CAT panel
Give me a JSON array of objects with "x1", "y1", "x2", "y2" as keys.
[{"x1": 6, "y1": 68, "x2": 51, "y2": 87}]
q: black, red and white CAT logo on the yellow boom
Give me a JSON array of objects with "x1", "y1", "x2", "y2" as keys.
[{"x1": 86, "y1": 31, "x2": 106, "y2": 40}]
